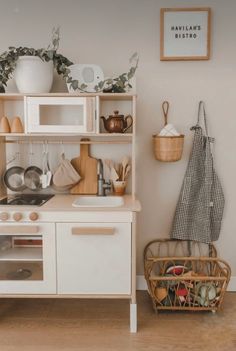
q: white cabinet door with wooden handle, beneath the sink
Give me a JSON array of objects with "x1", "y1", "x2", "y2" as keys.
[{"x1": 56, "y1": 223, "x2": 131, "y2": 294}]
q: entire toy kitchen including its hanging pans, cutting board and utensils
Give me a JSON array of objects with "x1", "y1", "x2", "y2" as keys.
[{"x1": 0, "y1": 93, "x2": 140, "y2": 332}]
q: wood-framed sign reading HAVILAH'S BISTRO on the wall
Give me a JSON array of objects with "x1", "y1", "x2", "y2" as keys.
[{"x1": 160, "y1": 7, "x2": 211, "y2": 61}]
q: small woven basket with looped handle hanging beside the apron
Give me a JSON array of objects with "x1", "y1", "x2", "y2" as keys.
[{"x1": 152, "y1": 101, "x2": 184, "y2": 162}]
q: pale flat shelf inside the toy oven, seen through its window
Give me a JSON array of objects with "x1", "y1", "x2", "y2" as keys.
[{"x1": 0, "y1": 247, "x2": 43, "y2": 261}]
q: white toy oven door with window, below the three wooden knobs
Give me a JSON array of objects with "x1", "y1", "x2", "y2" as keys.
[{"x1": 0, "y1": 223, "x2": 56, "y2": 294}]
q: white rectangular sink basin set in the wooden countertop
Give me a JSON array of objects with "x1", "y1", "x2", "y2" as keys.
[{"x1": 72, "y1": 196, "x2": 124, "y2": 207}]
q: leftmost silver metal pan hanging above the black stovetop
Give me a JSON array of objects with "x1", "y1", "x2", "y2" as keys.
[{"x1": 3, "y1": 166, "x2": 26, "y2": 191}]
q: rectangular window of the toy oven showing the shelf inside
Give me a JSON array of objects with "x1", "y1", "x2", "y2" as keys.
[{"x1": 0, "y1": 235, "x2": 43, "y2": 280}]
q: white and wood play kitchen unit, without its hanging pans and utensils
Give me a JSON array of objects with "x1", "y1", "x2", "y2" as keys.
[{"x1": 0, "y1": 93, "x2": 140, "y2": 332}]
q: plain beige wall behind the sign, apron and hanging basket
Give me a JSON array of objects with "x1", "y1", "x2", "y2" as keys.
[{"x1": 0, "y1": 0, "x2": 236, "y2": 275}]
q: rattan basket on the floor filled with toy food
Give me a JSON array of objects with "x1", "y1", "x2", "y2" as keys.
[{"x1": 144, "y1": 239, "x2": 231, "y2": 312}]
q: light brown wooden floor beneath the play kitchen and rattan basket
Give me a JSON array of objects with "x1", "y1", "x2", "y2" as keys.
[{"x1": 0, "y1": 292, "x2": 236, "y2": 351}]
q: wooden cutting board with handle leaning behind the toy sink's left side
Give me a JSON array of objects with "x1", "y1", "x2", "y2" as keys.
[{"x1": 70, "y1": 139, "x2": 97, "y2": 194}]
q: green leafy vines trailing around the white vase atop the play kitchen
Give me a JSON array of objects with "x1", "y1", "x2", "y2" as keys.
[{"x1": 0, "y1": 28, "x2": 138, "y2": 93}]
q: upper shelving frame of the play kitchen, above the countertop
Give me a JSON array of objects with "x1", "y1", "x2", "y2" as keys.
[{"x1": 0, "y1": 92, "x2": 137, "y2": 198}]
